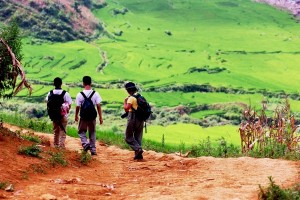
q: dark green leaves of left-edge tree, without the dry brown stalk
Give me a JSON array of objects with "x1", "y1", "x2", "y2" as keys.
[{"x1": 0, "y1": 21, "x2": 23, "y2": 97}]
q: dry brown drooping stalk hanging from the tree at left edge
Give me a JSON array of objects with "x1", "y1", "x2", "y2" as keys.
[{"x1": 0, "y1": 38, "x2": 32, "y2": 95}]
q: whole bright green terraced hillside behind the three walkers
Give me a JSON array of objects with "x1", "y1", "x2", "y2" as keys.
[{"x1": 2, "y1": 0, "x2": 300, "y2": 147}]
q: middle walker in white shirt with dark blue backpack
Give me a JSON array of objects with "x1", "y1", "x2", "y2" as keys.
[{"x1": 75, "y1": 76, "x2": 103, "y2": 156}]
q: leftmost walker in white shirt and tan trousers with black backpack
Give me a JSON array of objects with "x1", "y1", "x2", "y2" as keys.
[{"x1": 46, "y1": 77, "x2": 72, "y2": 149}]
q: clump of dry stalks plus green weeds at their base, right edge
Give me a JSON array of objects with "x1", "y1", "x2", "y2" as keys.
[{"x1": 239, "y1": 99, "x2": 300, "y2": 158}]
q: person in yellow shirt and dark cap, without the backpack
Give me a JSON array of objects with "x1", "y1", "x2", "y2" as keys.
[{"x1": 123, "y1": 82, "x2": 144, "y2": 160}]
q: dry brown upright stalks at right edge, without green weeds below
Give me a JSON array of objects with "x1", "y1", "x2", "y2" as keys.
[{"x1": 239, "y1": 99, "x2": 300, "y2": 153}]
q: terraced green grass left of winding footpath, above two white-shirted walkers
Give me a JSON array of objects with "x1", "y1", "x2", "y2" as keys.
[{"x1": 23, "y1": 40, "x2": 102, "y2": 83}]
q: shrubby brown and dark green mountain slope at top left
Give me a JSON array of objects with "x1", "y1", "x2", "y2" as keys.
[{"x1": 0, "y1": 0, "x2": 106, "y2": 41}]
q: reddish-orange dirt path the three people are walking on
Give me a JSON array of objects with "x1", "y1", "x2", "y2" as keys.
[{"x1": 0, "y1": 125, "x2": 300, "y2": 200}]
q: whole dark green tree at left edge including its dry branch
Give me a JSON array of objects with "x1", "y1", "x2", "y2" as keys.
[{"x1": 0, "y1": 20, "x2": 31, "y2": 97}]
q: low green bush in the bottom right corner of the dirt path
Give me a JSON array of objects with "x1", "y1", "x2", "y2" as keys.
[{"x1": 258, "y1": 177, "x2": 300, "y2": 200}]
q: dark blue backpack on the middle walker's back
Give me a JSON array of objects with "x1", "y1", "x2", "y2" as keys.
[{"x1": 80, "y1": 91, "x2": 97, "y2": 121}]
